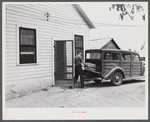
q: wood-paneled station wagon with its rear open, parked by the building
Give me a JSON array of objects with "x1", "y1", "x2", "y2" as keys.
[{"x1": 83, "y1": 49, "x2": 145, "y2": 86}]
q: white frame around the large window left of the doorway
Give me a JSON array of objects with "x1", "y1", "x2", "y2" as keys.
[{"x1": 16, "y1": 24, "x2": 38, "y2": 66}]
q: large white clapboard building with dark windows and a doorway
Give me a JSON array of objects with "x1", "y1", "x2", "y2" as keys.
[{"x1": 3, "y1": 2, "x2": 94, "y2": 99}]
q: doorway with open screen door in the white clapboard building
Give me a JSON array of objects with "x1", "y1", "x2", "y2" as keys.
[{"x1": 54, "y1": 40, "x2": 74, "y2": 86}]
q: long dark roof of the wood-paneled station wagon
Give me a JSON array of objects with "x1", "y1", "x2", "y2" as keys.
[{"x1": 86, "y1": 49, "x2": 138, "y2": 54}]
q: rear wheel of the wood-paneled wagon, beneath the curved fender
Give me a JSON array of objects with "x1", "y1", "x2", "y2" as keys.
[{"x1": 111, "y1": 72, "x2": 123, "y2": 86}]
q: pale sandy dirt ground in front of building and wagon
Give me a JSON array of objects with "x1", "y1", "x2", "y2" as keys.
[{"x1": 5, "y1": 80, "x2": 145, "y2": 108}]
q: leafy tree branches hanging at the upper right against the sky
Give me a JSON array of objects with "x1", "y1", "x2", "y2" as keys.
[{"x1": 109, "y1": 4, "x2": 145, "y2": 21}]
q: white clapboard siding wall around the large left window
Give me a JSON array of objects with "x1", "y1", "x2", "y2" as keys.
[{"x1": 5, "y1": 4, "x2": 89, "y2": 86}]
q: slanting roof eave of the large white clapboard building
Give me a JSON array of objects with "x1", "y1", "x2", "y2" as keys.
[{"x1": 73, "y1": 4, "x2": 95, "y2": 29}]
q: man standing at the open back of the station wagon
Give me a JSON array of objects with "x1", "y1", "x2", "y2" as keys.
[{"x1": 74, "y1": 51, "x2": 87, "y2": 88}]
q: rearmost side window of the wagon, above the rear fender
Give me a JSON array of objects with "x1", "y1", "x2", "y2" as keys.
[{"x1": 104, "y1": 53, "x2": 120, "y2": 60}]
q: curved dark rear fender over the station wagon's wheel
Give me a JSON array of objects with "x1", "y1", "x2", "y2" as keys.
[{"x1": 103, "y1": 66, "x2": 125, "y2": 80}]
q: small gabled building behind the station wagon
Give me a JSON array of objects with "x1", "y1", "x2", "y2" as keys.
[{"x1": 89, "y1": 38, "x2": 120, "y2": 49}]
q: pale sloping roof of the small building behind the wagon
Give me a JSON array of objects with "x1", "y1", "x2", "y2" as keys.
[{"x1": 90, "y1": 38, "x2": 120, "y2": 49}]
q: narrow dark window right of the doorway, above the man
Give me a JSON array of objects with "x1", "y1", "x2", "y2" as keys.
[{"x1": 75, "y1": 35, "x2": 84, "y2": 57}]
